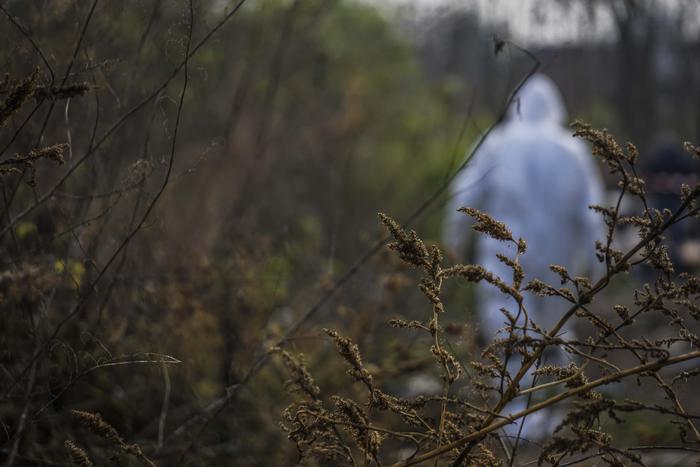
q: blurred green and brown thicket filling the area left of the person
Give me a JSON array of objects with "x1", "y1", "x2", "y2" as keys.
[{"x1": 0, "y1": 0, "x2": 484, "y2": 465}]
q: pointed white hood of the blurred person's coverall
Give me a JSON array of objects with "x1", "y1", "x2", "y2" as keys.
[{"x1": 508, "y1": 74, "x2": 567, "y2": 125}]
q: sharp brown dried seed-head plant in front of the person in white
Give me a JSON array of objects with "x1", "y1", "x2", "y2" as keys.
[{"x1": 282, "y1": 122, "x2": 700, "y2": 466}]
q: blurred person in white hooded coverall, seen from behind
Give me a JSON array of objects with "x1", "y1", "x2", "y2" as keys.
[{"x1": 444, "y1": 75, "x2": 605, "y2": 439}]
